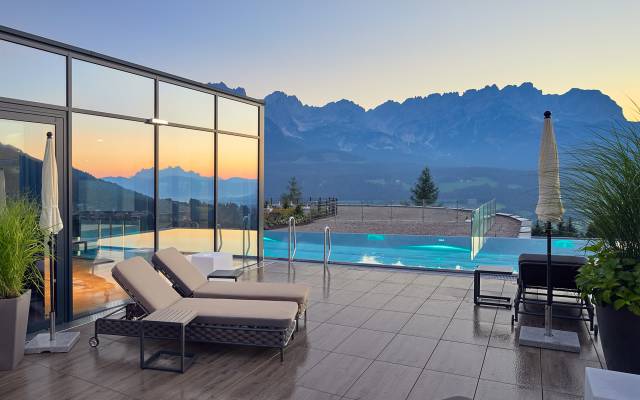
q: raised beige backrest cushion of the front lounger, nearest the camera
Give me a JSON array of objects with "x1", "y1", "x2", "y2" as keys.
[{"x1": 111, "y1": 257, "x2": 182, "y2": 313}]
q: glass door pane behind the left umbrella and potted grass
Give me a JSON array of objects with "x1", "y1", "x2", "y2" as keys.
[{"x1": 0, "y1": 119, "x2": 55, "y2": 330}]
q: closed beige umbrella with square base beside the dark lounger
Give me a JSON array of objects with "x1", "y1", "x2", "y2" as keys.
[{"x1": 519, "y1": 111, "x2": 580, "y2": 353}]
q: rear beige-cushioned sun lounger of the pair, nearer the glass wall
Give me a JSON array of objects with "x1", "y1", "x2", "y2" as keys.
[{"x1": 152, "y1": 247, "x2": 309, "y2": 317}]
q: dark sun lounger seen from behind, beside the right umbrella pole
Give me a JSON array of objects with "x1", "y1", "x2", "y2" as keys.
[{"x1": 512, "y1": 254, "x2": 597, "y2": 334}]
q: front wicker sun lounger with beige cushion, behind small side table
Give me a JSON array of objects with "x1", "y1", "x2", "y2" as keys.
[{"x1": 90, "y1": 257, "x2": 298, "y2": 359}]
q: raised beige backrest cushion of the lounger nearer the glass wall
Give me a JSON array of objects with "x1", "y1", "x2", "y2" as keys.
[{"x1": 151, "y1": 247, "x2": 207, "y2": 296}]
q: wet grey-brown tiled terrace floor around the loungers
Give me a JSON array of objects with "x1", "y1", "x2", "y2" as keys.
[{"x1": 0, "y1": 263, "x2": 602, "y2": 400}]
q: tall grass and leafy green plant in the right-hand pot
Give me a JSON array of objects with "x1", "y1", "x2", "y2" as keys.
[{"x1": 566, "y1": 117, "x2": 640, "y2": 315}]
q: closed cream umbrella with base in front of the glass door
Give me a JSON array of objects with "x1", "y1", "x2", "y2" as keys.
[{"x1": 25, "y1": 132, "x2": 80, "y2": 354}]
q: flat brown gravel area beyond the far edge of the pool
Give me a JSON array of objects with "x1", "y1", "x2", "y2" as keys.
[{"x1": 277, "y1": 206, "x2": 521, "y2": 237}]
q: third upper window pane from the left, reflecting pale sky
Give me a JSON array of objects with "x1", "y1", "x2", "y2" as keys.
[{"x1": 159, "y1": 82, "x2": 216, "y2": 129}]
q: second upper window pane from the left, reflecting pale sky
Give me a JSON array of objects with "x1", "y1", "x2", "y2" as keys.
[{"x1": 72, "y1": 59, "x2": 154, "y2": 118}]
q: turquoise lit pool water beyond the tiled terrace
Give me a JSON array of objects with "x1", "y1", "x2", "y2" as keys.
[{"x1": 264, "y1": 231, "x2": 587, "y2": 271}]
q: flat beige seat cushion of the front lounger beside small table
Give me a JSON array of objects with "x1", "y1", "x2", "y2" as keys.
[{"x1": 172, "y1": 298, "x2": 298, "y2": 328}]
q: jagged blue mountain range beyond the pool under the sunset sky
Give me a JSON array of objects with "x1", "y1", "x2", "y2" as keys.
[{"x1": 211, "y1": 82, "x2": 627, "y2": 216}]
